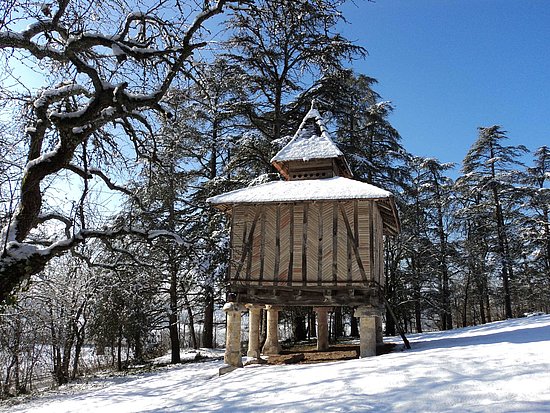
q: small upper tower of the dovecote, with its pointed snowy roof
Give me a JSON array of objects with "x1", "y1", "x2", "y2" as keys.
[{"x1": 271, "y1": 101, "x2": 353, "y2": 181}]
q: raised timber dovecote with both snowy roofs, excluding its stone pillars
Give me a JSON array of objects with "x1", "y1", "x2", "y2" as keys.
[{"x1": 209, "y1": 102, "x2": 399, "y2": 307}]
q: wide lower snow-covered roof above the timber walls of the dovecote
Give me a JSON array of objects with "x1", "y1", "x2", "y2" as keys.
[{"x1": 207, "y1": 176, "x2": 392, "y2": 205}]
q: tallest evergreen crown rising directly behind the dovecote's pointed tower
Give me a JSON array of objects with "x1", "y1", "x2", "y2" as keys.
[{"x1": 227, "y1": 0, "x2": 365, "y2": 176}]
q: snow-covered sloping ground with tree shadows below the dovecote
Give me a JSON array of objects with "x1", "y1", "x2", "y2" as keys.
[{"x1": 4, "y1": 315, "x2": 550, "y2": 413}]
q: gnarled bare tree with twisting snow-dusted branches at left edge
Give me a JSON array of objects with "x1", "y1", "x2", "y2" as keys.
[{"x1": 0, "y1": 0, "x2": 241, "y2": 303}]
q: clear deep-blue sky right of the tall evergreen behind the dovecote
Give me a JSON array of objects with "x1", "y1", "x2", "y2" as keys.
[{"x1": 343, "y1": 0, "x2": 550, "y2": 164}]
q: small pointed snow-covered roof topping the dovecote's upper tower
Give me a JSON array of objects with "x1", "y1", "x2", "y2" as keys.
[{"x1": 271, "y1": 102, "x2": 344, "y2": 162}]
